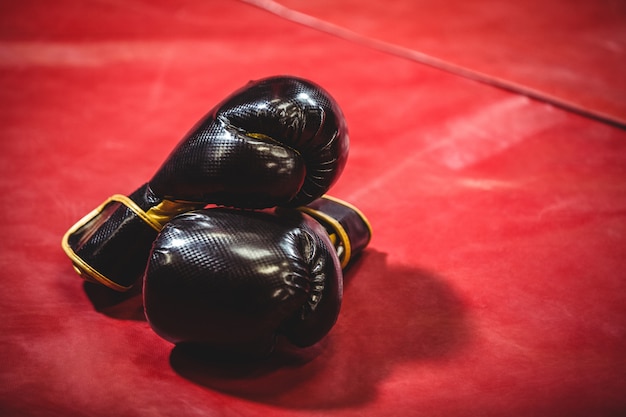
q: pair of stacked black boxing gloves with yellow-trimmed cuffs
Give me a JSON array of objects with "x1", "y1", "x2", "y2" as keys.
[{"x1": 63, "y1": 77, "x2": 371, "y2": 356}]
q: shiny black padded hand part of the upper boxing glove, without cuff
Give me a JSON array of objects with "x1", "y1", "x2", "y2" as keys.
[{"x1": 150, "y1": 77, "x2": 349, "y2": 208}]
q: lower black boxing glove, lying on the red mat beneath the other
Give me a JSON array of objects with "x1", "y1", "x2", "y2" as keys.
[{"x1": 143, "y1": 197, "x2": 371, "y2": 358}]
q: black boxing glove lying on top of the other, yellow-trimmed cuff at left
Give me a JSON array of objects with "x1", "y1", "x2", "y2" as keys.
[{"x1": 62, "y1": 77, "x2": 348, "y2": 291}]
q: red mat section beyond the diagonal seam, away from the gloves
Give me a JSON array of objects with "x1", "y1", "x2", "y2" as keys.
[{"x1": 258, "y1": 0, "x2": 626, "y2": 125}]
